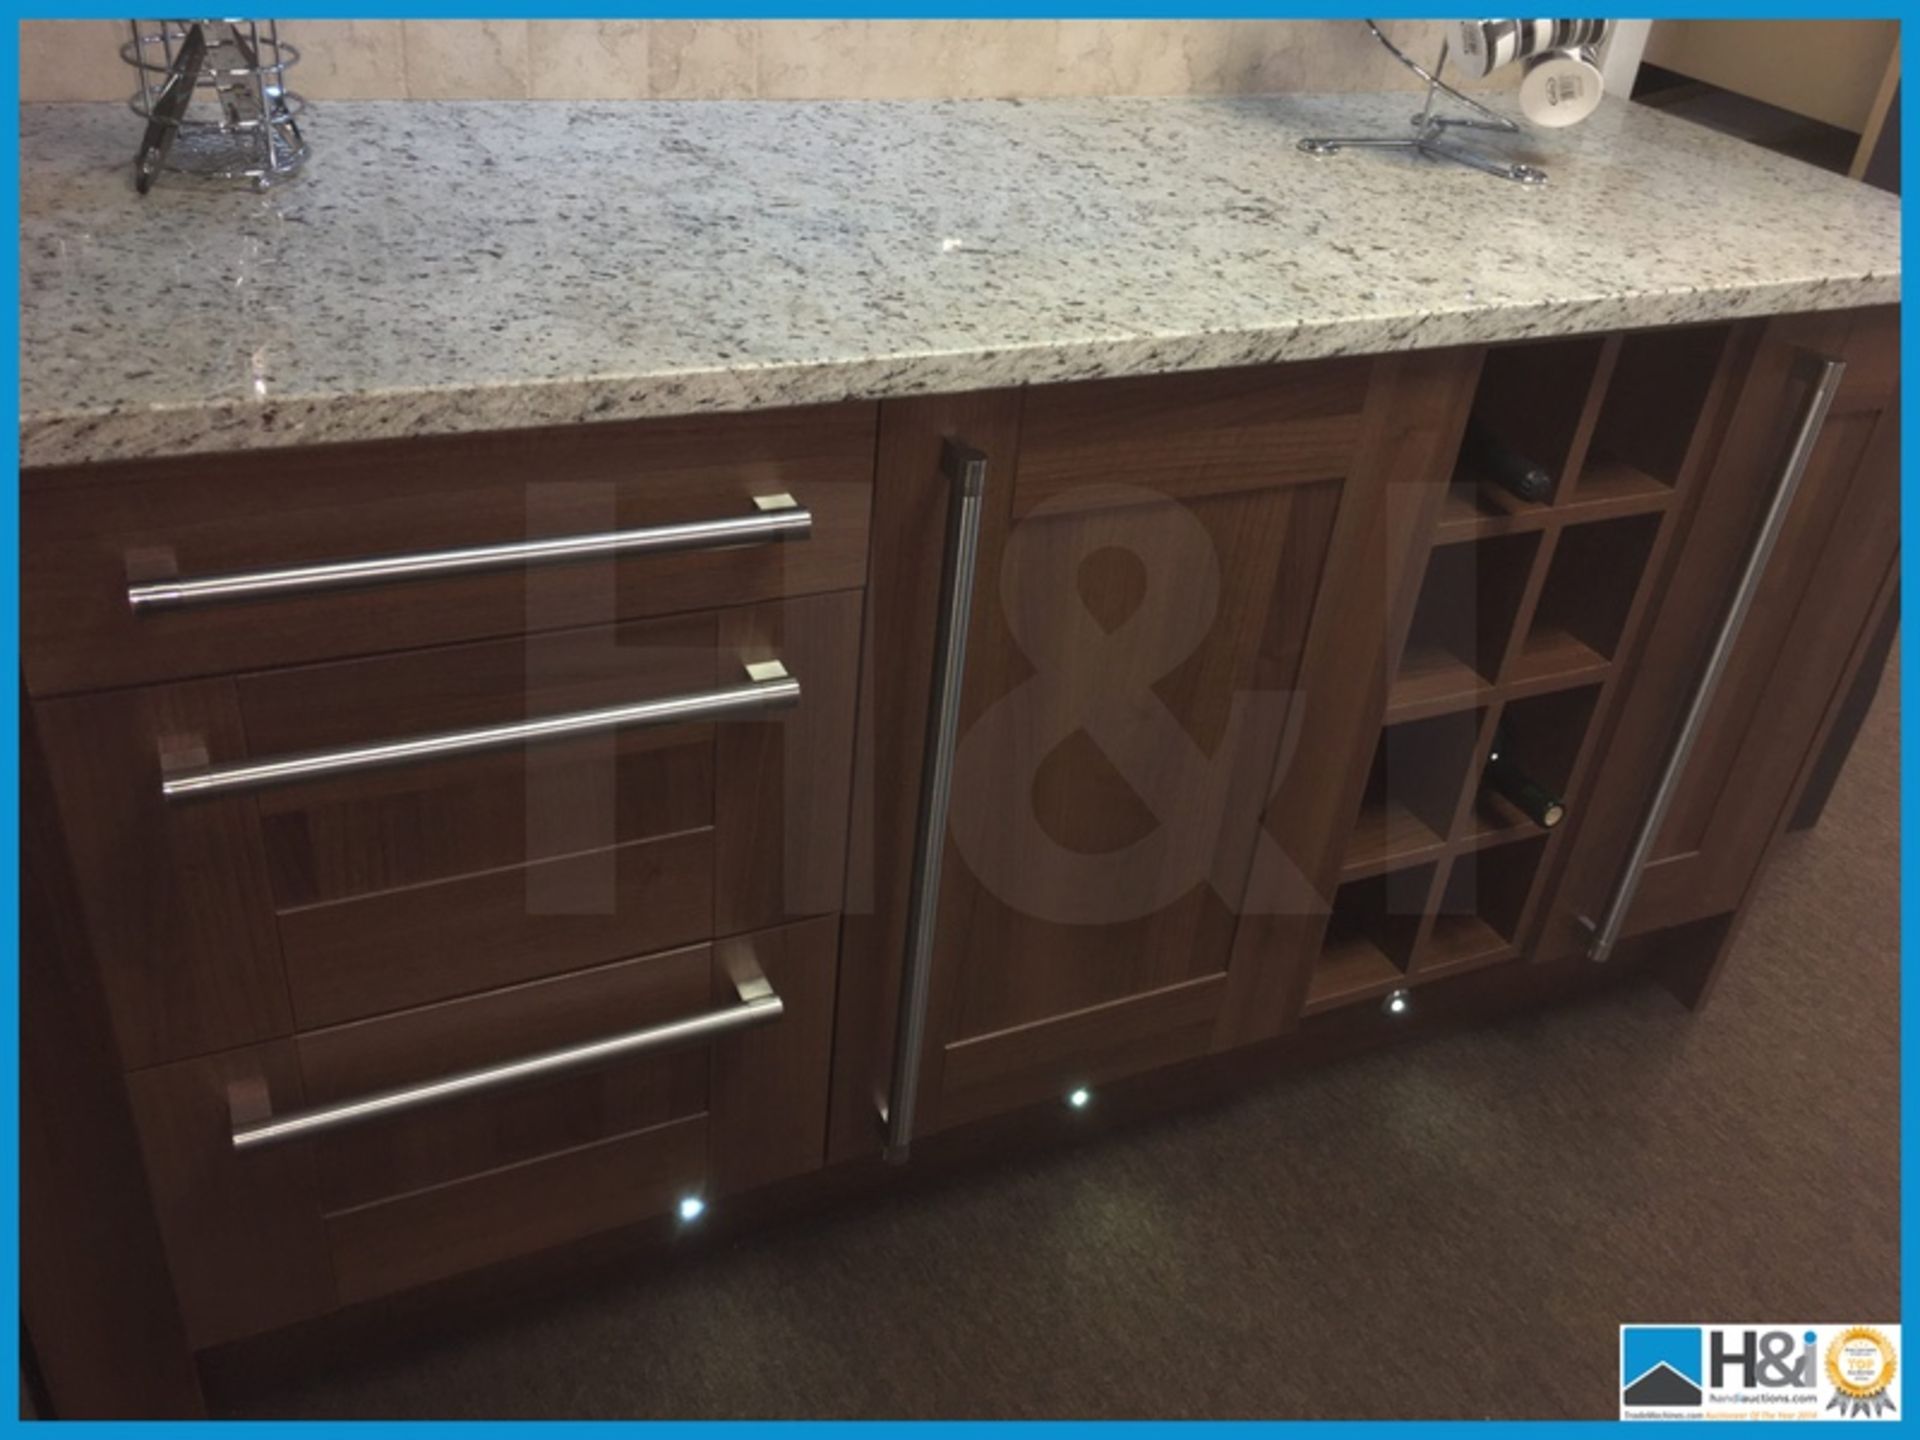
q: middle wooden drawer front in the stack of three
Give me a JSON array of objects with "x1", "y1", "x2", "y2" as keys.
[{"x1": 36, "y1": 591, "x2": 860, "y2": 1069}]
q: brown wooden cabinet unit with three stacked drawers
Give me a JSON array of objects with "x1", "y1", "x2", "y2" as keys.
[{"x1": 25, "y1": 405, "x2": 876, "y2": 1348}]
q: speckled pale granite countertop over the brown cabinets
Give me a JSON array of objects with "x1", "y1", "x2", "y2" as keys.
[{"x1": 21, "y1": 94, "x2": 1901, "y2": 465}]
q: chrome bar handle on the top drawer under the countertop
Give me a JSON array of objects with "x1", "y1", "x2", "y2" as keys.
[{"x1": 127, "y1": 493, "x2": 814, "y2": 612}]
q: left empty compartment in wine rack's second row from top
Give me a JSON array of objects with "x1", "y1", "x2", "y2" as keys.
[{"x1": 1388, "y1": 536, "x2": 1540, "y2": 710}]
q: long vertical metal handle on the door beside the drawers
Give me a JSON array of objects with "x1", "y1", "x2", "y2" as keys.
[{"x1": 885, "y1": 440, "x2": 987, "y2": 1164}]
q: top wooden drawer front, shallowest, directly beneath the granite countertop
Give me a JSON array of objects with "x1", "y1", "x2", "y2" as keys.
[{"x1": 23, "y1": 405, "x2": 876, "y2": 693}]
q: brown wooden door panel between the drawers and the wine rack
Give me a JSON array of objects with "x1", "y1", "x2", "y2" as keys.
[{"x1": 902, "y1": 355, "x2": 1471, "y2": 1129}]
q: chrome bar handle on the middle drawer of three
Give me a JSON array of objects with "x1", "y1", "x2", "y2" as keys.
[{"x1": 159, "y1": 660, "x2": 801, "y2": 801}]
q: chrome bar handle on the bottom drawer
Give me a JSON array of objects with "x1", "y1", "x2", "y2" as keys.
[{"x1": 234, "y1": 972, "x2": 785, "y2": 1150}]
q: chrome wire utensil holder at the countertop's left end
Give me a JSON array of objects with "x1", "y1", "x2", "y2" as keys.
[{"x1": 121, "y1": 19, "x2": 309, "y2": 188}]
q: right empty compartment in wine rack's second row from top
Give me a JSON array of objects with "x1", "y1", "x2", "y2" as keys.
[{"x1": 1509, "y1": 515, "x2": 1661, "y2": 682}]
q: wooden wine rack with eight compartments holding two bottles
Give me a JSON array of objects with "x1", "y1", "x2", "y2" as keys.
[{"x1": 1302, "y1": 326, "x2": 1734, "y2": 1016}]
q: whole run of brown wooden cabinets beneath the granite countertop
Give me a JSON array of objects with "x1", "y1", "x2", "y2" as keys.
[{"x1": 23, "y1": 311, "x2": 1899, "y2": 1404}]
